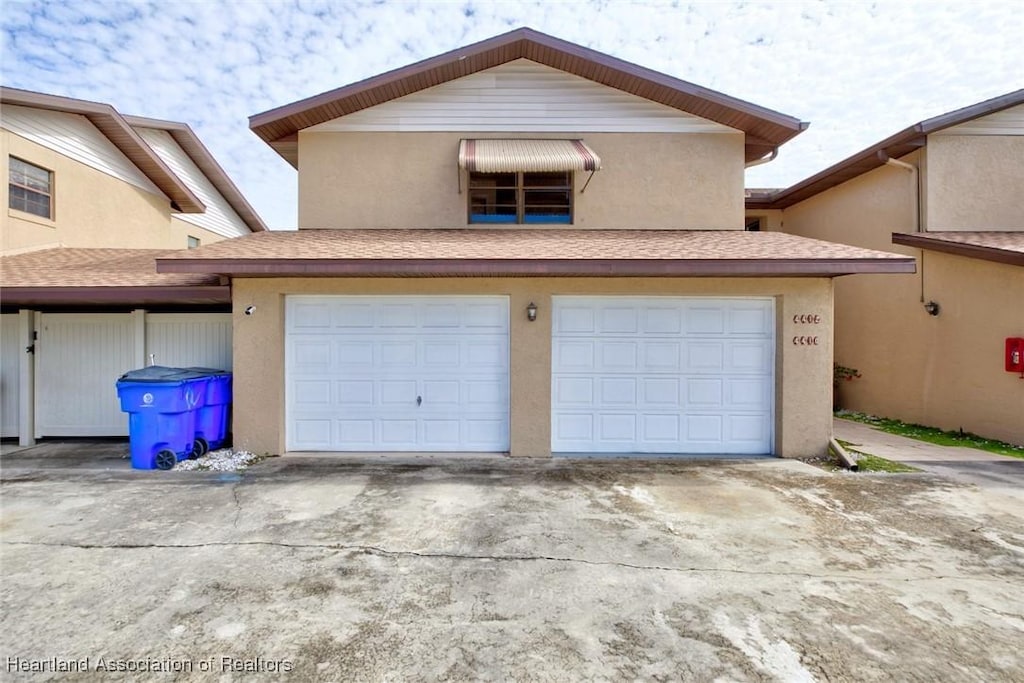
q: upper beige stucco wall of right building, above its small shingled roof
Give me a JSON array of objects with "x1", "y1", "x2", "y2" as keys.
[{"x1": 927, "y1": 135, "x2": 1024, "y2": 230}]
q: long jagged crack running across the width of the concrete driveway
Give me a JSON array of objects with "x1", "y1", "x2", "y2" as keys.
[{"x1": 0, "y1": 541, "x2": 1006, "y2": 584}]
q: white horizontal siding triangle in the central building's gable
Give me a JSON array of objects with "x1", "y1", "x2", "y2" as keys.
[{"x1": 306, "y1": 59, "x2": 742, "y2": 135}]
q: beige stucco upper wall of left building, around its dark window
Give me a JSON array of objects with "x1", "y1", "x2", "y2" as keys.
[{"x1": 0, "y1": 130, "x2": 224, "y2": 254}]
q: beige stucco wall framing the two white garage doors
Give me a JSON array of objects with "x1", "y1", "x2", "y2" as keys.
[{"x1": 232, "y1": 278, "x2": 833, "y2": 457}]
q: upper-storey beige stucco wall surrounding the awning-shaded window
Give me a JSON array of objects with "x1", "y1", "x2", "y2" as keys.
[{"x1": 299, "y1": 132, "x2": 743, "y2": 229}]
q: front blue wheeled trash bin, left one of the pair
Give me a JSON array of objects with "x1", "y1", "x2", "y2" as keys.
[{"x1": 117, "y1": 366, "x2": 209, "y2": 470}]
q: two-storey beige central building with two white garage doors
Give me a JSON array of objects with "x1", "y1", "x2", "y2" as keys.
[{"x1": 158, "y1": 29, "x2": 914, "y2": 457}]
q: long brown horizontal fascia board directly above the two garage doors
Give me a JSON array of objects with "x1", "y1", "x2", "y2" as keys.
[{"x1": 157, "y1": 257, "x2": 915, "y2": 278}]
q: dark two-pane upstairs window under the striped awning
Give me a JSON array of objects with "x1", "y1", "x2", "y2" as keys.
[{"x1": 469, "y1": 171, "x2": 572, "y2": 224}]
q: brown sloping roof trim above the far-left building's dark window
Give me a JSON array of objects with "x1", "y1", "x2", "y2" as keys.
[{"x1": 0, "y1": 87, "x2": 206, "y2": 213}]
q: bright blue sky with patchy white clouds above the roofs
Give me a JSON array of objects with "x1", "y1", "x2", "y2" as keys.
[{"x1": 0, "y1": 0, "x2": 1024, "y2": 227}]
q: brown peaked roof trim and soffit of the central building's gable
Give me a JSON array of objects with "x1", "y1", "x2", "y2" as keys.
[{"x1": 249, "y1": 28, "x2": 808, "y2": 167}]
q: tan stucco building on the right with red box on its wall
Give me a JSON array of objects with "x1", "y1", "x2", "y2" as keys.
[{"x1": 746, "y1": 90, "x2": 1024, "y2": 443}]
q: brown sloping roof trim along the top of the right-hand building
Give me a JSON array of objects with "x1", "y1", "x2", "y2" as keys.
[{"x1": 746, "y1": 89, "x2": 1024, "y2": 209}]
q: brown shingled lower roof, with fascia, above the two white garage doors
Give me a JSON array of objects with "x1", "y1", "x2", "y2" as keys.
[{"x1": 157, "y1": 228, "x2": 914, "y2": 276}]
